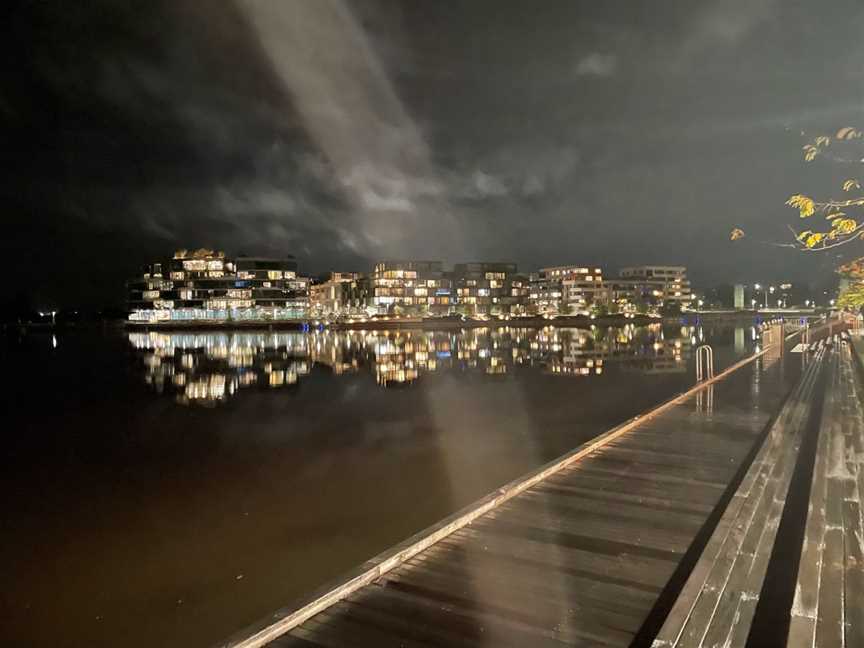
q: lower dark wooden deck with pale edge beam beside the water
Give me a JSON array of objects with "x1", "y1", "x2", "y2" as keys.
[{"x1": 226, "y1": 344, "x2": 796, "y2": 648}]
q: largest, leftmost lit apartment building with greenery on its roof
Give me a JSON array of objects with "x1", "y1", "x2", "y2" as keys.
[{"x1": 128, "y1": 249, "x2": 309, "y2": 322}]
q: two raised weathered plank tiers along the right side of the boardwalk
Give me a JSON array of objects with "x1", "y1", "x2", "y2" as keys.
[{"x1": 653, "y1": 337, "x2": 864, "y2": 648}]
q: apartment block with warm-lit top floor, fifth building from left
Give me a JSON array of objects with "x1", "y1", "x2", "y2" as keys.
[{"x1": 529, "y1": 265, "x2": 605, "y2": 315}]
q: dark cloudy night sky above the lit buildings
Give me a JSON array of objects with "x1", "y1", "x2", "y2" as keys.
[{"x1": 6, "y1": 0, "x2": 864, "y2": 306}]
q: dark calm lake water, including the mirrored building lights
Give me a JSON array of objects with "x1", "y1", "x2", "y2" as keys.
[{"x1": 0, "y1": 325, "x2": 757, "y2": 648}]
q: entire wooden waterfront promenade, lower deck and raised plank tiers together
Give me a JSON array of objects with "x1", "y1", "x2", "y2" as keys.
[{"x1": 223, "y1": 324, "x2": 864, "y2": 648}]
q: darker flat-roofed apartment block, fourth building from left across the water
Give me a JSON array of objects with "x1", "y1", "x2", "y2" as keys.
[{"x1": 453, "y1": 262, "x2": 523, "y2": 315}]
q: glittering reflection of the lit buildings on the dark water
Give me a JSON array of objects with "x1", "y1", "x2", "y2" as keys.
[{"x1": 129, "y1": 324, "x2": 724, "y2": 405}]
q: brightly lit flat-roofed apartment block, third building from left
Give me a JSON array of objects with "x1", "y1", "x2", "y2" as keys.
[{"x1": 371, "y1": 261, "x2": 452, "y2": 314}]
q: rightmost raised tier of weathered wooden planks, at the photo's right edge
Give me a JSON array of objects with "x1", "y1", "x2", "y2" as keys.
[{"x1": 788, "y1": 340, "x2": 864, "y2": 648}]
